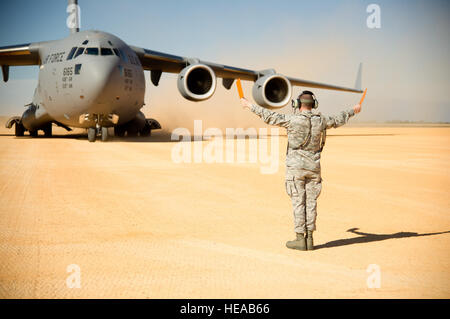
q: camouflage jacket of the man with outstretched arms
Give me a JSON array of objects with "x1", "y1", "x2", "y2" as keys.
[{"x1": 251, "y1": 104, "x2": 355, "y2": 178}]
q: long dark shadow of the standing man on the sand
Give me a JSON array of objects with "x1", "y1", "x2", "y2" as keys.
[{"x1": 314, "y1": 228, "x2": 450, "y2": 249}]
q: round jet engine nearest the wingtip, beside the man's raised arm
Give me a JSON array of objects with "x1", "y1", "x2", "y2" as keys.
[{"x1": 252, "y1": 74, "x2": 292, "y2": 109}]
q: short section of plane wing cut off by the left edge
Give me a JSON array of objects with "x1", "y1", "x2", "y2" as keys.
[{"x1": 0, "y1": 43, "x2": 40, "y2": 82}]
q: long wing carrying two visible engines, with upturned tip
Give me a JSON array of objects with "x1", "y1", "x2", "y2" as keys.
[{"x1": 131, "y1": 46, "x2": 363, "y2": 93}]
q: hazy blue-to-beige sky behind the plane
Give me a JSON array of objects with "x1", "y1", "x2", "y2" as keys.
[{"x1": 0, "y1": 0, "x2": 450, "y2": 121}]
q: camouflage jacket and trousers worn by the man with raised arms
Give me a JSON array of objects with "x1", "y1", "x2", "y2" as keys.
[{"x1": 251, "y1": 105, "x2": 355, "y2": 233}]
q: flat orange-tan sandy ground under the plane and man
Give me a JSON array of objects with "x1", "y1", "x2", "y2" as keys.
[{"x1": 0, "y1": 122, "x2": 450, "y2": 298}]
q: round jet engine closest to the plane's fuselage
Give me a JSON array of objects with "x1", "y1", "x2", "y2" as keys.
[{"x1": 177, "y1": 64, "x2": 217, "y2": 101}]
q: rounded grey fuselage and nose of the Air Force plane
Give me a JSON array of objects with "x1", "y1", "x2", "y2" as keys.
[{"x1": 33, "y1": 31, "x2": 145, "y2": 128}]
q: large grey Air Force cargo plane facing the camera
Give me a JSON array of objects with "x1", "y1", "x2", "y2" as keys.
[{"x1": 0, "y1": 0, "x2": 362, "y2": 142}]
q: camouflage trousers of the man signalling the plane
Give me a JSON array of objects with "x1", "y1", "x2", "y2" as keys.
[{"x1": 286, "y1": 170, "x2": 322, "y2": 233}]
